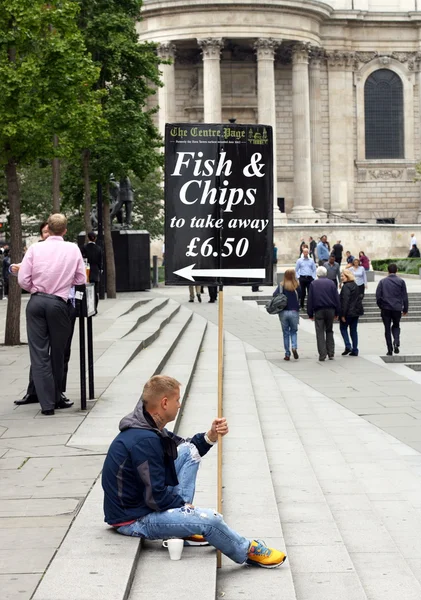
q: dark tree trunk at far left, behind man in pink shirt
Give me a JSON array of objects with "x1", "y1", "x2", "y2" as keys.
[{"x1": 4, "y1": 159, "x2": 22, "y2": 346}]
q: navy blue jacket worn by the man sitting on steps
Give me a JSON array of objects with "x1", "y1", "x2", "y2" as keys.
[{"x1": 102, "y1": 406, "x2": 212, "y2": 525}]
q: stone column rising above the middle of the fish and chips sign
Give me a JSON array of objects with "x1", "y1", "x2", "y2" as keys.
[{"x1": 197, "y1": 38, "x2": 224, "y2": 123}]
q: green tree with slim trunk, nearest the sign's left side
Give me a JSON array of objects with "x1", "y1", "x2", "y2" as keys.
[{"x1": 79, "y1": 0, "x2": 162, "y2": 297}]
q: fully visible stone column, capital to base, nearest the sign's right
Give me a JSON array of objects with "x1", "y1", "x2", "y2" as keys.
[{"x1": 291, "y1": 43, "x2": 316, "y2": 223}]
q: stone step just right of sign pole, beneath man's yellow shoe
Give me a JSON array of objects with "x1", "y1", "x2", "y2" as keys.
[{"x1": 217, "y1": 333, "x2": 296, "y2": 600}]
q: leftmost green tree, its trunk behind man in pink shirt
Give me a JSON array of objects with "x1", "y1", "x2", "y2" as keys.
[{"x1": 0, "y1": 0, "x2": 101, "y2": 345}]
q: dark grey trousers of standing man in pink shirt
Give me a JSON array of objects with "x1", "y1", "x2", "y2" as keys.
[{"x1": 26, "y1": 294, "x2": 71, "y2": 410}]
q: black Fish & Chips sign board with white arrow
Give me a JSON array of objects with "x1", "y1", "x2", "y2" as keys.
[{"x1": 165, "y1": 123, "x2": 273, "y2": 285}]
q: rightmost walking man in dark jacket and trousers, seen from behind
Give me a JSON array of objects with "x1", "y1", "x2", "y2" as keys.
[{"x1": 376, "y1": 263, "x2": 408, "y2": 356}]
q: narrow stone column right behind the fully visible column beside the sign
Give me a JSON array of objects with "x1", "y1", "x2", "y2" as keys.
[{"x1": 310, "y1": 47, "x2": 324, "y2": 213}]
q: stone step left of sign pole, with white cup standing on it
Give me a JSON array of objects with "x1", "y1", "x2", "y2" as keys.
[{"x1": 128, "y1": 324, "x2": 218, "y2": 600}]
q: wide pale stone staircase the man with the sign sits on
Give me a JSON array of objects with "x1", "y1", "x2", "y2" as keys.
[{"x1": 33, "y1": 295, "x2": 421, "y2": 600}]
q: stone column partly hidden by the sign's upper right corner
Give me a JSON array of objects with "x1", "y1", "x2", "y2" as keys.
[{"x1": 254, "y1": 38, "x2": 285, "y2": 225}]
